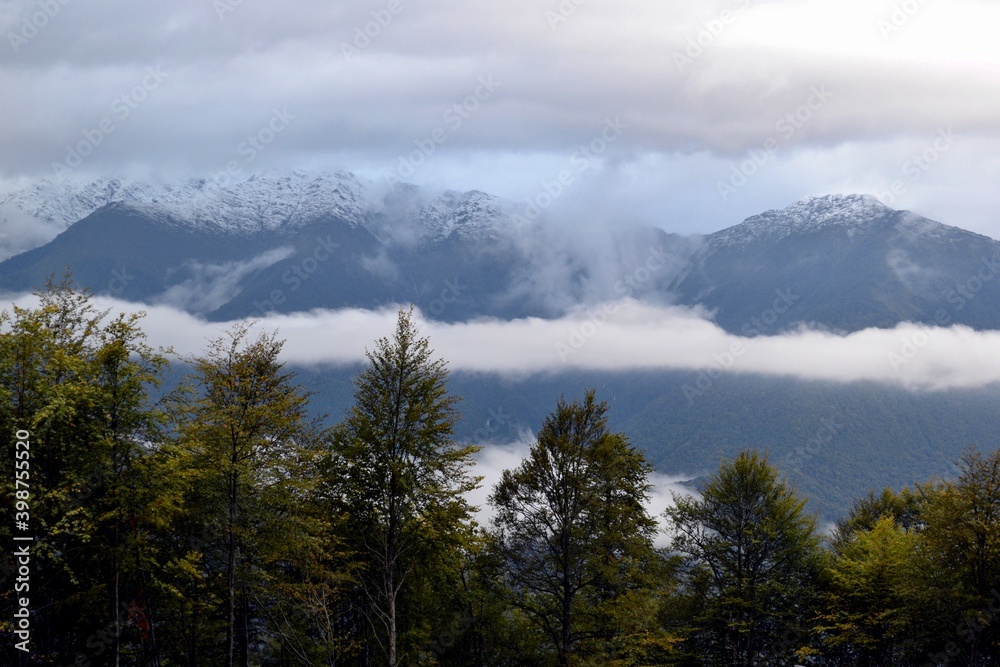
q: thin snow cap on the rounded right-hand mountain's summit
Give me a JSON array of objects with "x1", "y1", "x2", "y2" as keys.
[{"x1": 711, "y1": 194, "x2": 895, "y2": 247}]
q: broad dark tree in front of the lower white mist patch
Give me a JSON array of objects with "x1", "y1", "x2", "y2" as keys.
[{"x1": 490, "y1": 390, "x2": 661, "y2": 666}]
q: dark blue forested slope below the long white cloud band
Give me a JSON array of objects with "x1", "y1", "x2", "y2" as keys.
[{"x1": 276, "y1": 368, "x2": 1000, "y2": 521}]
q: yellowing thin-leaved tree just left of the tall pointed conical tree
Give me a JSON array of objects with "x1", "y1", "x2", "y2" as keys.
[{"x1": 164, "y1": 324, "x2": 319, "y2": 667}]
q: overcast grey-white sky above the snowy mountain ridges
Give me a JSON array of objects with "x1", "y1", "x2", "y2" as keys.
[{"x1": 0, "y1": 0, "x2": 1000, "y2": 238}]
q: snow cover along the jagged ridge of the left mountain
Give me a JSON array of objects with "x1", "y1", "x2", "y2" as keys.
[{"x1": 0, "y1": 171, "x2": 504, "y2": 241}]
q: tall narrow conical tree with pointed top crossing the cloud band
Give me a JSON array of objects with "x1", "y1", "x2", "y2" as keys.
[{"x1": 329, "y1": 310, "x2": 479, "y2": 667}]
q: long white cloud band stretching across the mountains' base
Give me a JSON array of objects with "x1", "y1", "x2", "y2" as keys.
[{"x1": 8, "y1": 297, "x2": 1000, "y2": 390}]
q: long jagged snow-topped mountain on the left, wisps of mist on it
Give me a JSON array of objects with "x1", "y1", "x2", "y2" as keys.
[{"x1": 0, "y1": 172, "x2": 691, "y2": 320}]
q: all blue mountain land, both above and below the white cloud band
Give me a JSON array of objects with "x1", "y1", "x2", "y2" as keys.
[{"x1": 0, "y1": 177, "x2": 1000, "y2": 519}]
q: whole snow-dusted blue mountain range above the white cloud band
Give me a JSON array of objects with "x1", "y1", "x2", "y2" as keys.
[{"x1": 0, "y1": 181, "x2": 1000, "y2": 336}]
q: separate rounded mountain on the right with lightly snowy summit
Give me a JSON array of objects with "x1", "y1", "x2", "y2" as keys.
[{"x1": 672, "y1": 195, "x2": 1000, "y2": 335}]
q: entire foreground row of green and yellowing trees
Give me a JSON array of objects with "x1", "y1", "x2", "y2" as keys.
[{"x1": 0, "y1": 278, "x2": 1000, "y2": 667}]
